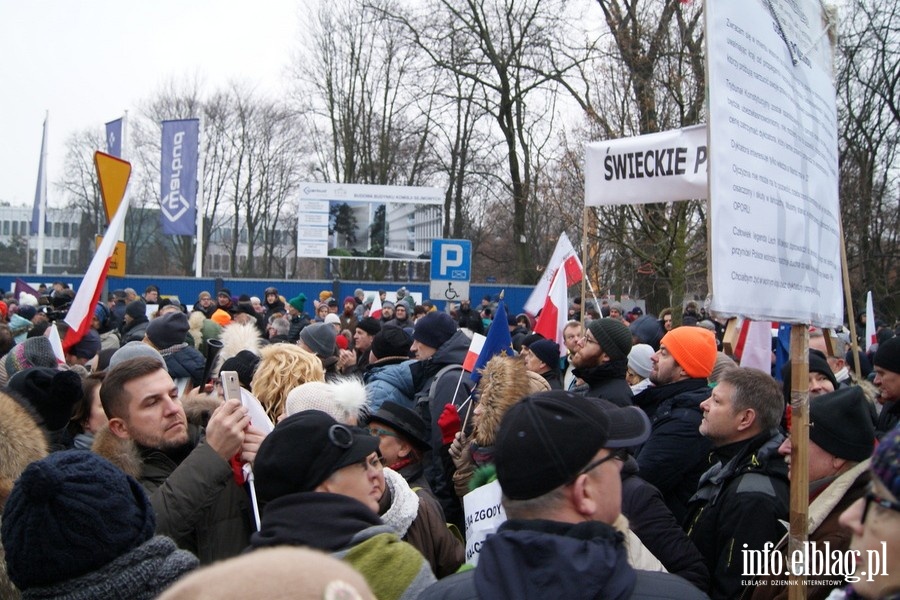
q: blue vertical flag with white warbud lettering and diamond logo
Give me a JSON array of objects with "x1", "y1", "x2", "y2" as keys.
[{"x1": 159, "y1": 119, "x2": 200, "y2": 235}]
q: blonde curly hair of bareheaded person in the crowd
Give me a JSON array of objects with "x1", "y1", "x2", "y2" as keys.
[{"x1": 250, "y1": 344, "x2": 325, "y2": 423}]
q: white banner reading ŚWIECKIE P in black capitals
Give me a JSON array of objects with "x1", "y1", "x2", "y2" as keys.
[{"x1": 584, "y1": 125, "x2": 708, "y2": 206}]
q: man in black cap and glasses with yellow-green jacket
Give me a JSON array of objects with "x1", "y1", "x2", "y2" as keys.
[{"x1": 250, "y1": 410, "x2": 435, "y2": 599}]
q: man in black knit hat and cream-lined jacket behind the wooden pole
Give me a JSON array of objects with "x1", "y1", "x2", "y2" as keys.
[{"x1": 753, "y1": 386, "x2": 875, "y2": 600}]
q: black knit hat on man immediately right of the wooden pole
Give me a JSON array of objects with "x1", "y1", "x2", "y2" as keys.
[{"x1": 809, "y1": 385, "x2": 875, "y2": 462}]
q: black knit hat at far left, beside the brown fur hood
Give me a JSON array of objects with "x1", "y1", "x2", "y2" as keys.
[{"x1": 7, "y1": 367, "x2": 84, "y2": 431}]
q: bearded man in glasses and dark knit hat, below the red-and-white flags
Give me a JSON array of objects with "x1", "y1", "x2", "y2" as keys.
[{"x1": 571, "y1": 319, "x2": 631, "y2": 406}]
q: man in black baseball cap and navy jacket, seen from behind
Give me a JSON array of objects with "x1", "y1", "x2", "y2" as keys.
[{"x1": 421, "y1": 391, "x2": 705, "y2": 600}]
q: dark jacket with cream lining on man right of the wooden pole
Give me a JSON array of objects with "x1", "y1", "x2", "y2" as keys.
[{"x1": 743, "y1": 459, "x2": 872, "y2": 600}]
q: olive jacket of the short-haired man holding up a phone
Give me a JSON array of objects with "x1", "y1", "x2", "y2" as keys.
[{"x1": 92, "y1": 400, "x2": 251, "y2": 564}]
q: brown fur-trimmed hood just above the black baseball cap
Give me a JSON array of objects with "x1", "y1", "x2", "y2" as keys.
[{"x1": 472, "y1": 355, "x2": 550, "y2": 448}]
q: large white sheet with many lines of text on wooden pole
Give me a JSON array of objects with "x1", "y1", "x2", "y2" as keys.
[{"x1": 704, "y1": 0, "x2": 842, "y2": 327}]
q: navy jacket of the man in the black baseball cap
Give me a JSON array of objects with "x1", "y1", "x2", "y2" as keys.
[{"x1": 420, "y1": 520, "x2": 706, "y2": 600}]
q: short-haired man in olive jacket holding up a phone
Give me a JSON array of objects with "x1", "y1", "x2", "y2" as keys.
[{"x1": 94, "y1": 358, "x2": 264, "y2": 564}]
